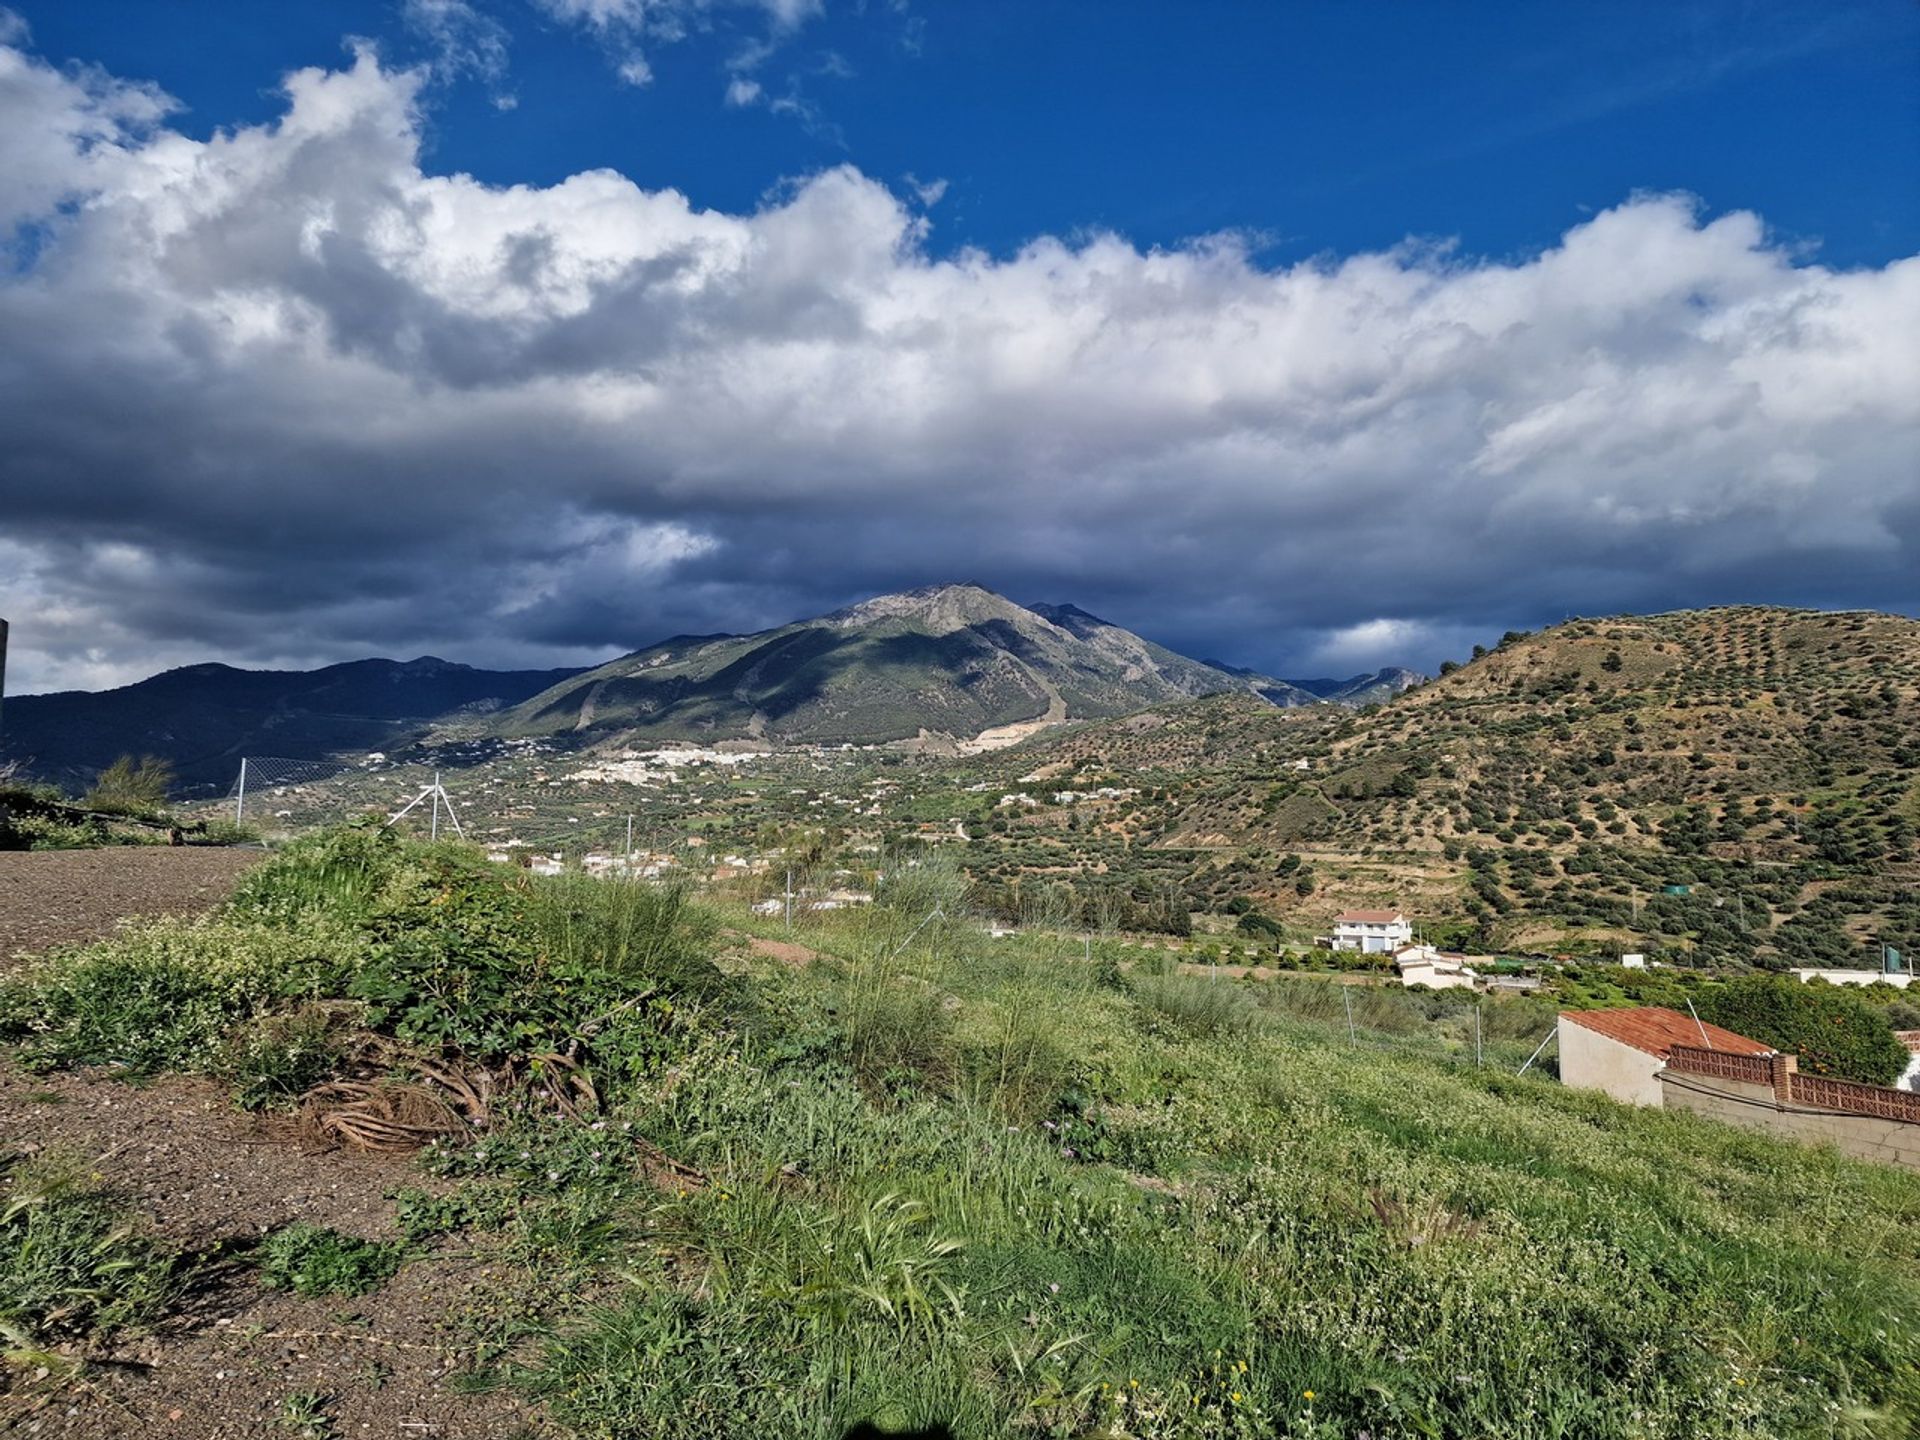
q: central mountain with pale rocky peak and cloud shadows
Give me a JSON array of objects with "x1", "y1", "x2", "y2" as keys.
[{"x1": 493, "y1": 584, "x2": 1315, "y2": 743}]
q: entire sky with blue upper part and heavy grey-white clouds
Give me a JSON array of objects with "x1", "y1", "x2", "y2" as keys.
[{"x1": 0, "y1": 0, "x2": 1920, "y2": 693}]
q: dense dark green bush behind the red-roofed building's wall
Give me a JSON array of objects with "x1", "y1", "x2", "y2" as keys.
[{"x1": 1699, "y1": 975, "x2": 1908, "y2": 1085}]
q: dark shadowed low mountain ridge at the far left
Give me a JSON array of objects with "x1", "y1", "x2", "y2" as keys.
[{"x1": 0, "y1": 655, "x2": 576, "y2": 789}]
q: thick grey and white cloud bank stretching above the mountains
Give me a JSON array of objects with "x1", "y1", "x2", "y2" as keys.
[{"x1": 0, "y1": 30, "x2": 1920, "y2": 689}]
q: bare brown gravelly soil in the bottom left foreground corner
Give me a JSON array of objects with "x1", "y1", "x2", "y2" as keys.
[{"x1": 0, "y1": 1066, "x2": 551, "y2": 1440}]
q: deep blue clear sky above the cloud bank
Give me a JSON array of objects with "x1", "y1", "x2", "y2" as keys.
[{"x1": 26, "y1": 0, "x2": 1920, "y2": 265}]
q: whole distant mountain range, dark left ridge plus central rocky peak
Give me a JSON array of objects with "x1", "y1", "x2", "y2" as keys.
[{"x1": 0, "y1": 584, "x2": 1421, "y2": 785}]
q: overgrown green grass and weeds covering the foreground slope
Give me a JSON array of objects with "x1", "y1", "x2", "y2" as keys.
[{"x1": 0, "y1": 841, "x2": 1920, "y2": 1440}]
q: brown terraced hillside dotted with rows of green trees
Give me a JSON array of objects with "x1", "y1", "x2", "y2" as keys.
[{"x1": 960, "y1": 607, "x2": 1920, "y2": 964}]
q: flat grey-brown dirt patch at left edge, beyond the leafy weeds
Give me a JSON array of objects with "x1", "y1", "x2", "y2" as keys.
[{"x1": 0, "y1": 845, "x2": 267, "y2": 970}]
